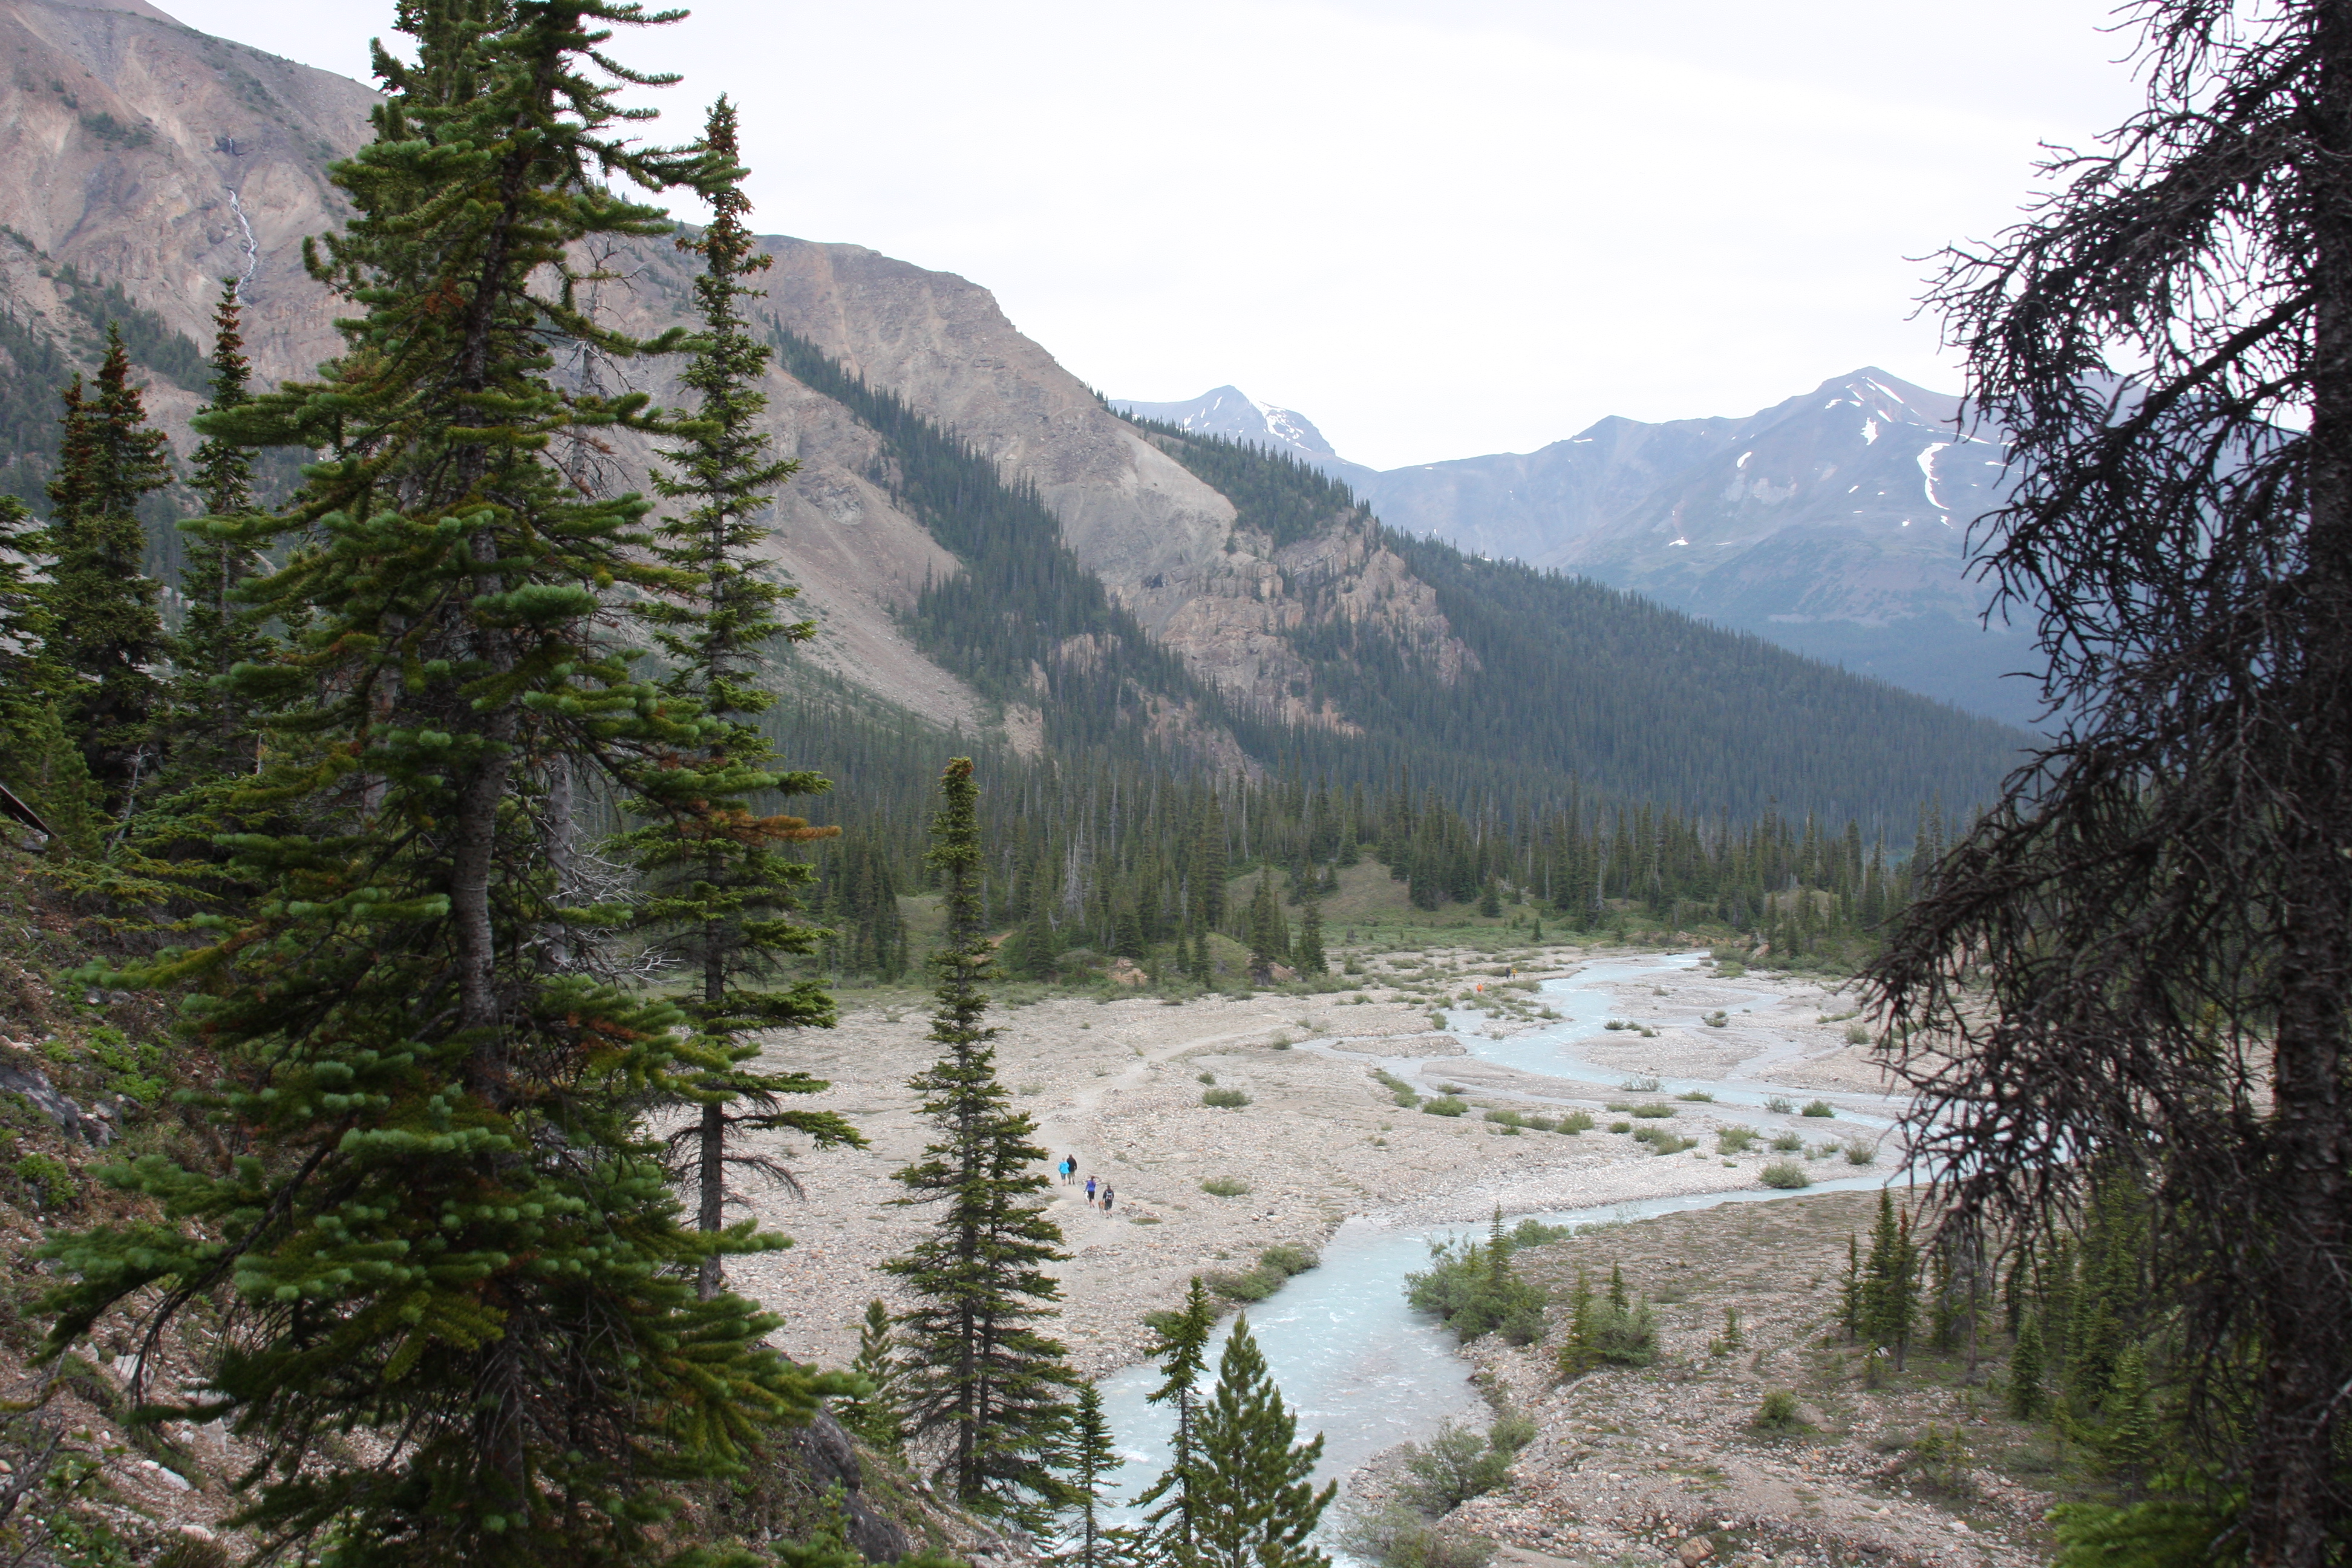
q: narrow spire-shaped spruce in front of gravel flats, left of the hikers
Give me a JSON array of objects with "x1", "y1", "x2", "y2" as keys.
[{"x1": 882, "y1": 757, "x2": 1077, "y2": 1530}]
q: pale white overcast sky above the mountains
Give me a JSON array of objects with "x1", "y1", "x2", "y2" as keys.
[{"x1": 162, "y1": 0, "x2": 2138, "y2": 468}]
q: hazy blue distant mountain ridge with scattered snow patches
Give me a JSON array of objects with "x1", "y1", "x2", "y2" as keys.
[{"x1": 1119, "y1": 367, "x2": 2037, "y2": 724}]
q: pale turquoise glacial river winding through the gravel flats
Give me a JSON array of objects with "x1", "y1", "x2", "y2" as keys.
[{"x1": 1101, "y1": 955, "x2": 1898, "y2": 1523}]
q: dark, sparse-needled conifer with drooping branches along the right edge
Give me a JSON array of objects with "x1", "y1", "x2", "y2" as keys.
[{"x1": 1870, "y1": 0, "x2": 2352, "y2": 1568}]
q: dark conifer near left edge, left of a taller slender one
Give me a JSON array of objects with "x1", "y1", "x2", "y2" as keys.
[{"x1": 47, "y1": 327, "x2": 172, "y2": 818}]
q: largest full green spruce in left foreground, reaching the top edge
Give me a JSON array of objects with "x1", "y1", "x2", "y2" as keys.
[{"x1": 47, "y1": 0, "x2": 847, "y2": 1568}]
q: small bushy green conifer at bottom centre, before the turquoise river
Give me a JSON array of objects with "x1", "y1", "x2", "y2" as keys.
[{"x1": 1197, "y1": 1316, "x2": 1338, "y2": 1568}]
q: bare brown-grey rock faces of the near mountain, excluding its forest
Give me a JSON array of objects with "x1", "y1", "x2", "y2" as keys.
[{"x1": 0, "y1": 0, "x2": 1465, "y2": 743}]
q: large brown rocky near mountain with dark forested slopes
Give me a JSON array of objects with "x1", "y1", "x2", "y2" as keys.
[{"x1": 0, "y1": 0, "x2": 2018, "y2": 828}]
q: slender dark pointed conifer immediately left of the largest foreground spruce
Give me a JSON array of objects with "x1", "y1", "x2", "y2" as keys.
[{"x1": 167, "y1": 278, "x2": 270, "y2": 785}]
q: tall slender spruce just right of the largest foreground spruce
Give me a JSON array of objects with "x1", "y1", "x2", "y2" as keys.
[{"x1": 626, "y1": 96, "x2": 866, "y2": 1298}]
